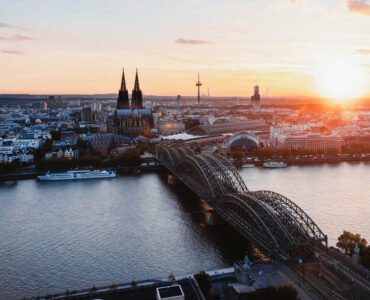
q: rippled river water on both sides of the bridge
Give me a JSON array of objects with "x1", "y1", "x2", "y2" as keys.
[{"x1": 0, "y1": 163, "x2": 370, "y2": 299}]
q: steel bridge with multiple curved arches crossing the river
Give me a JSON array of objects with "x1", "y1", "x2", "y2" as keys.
[{"x1": 156, "y1": 142, "x2": 327, "y2": 256}]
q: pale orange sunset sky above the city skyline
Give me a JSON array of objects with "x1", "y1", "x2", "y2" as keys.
[{"x1": 0, "y1": 0, "x2": 370, "y2": 97}]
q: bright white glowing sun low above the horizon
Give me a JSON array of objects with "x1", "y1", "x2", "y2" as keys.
[{"x1": 315, "y1": 58, "x2": 367, "y2": 103}]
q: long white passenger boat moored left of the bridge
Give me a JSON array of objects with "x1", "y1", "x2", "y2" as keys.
[{"x1": 37, "y1": 170, "x2": 116, "y2": 181}]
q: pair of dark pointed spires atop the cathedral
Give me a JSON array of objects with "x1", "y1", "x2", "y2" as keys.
[{"x1": 117, "y1": 69, "x2": 143, "y2": 109}]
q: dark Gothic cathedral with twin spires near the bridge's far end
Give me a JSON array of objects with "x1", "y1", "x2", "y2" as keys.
[{"x1": 114, "y1": 70, "x2": 154, "y2": 138}]
